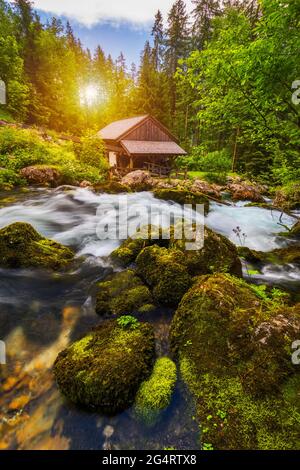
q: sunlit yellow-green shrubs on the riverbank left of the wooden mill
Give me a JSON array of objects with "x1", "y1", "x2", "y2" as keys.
[{"x1": 0, "y1": 127, "x2": 108, "y2": 189}]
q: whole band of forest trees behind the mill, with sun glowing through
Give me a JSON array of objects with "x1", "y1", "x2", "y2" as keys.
[{"x1": 0, "y1": 0, "x2": 300, "y2": 184}]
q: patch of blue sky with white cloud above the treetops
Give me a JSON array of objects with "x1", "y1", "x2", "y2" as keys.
[{"x1": 33, "y1": 0, "x2": 192, "y2": 67}]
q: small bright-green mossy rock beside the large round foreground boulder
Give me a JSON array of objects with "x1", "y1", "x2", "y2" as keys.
[{"x1": 134, "y1": 357, "x2": 177, "y2": 426}]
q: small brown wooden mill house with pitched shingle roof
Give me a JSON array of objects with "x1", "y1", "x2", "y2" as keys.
[{"x1": 98, "y1": 115, "x2": 186, "y2": 176}]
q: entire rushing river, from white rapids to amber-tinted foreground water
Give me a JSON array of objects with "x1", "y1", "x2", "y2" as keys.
[{"x1": 0, "y1": 188, "x2": 300, "y2": 449}]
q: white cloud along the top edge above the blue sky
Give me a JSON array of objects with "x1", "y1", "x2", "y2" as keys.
[{"x1": 34, "y1": 0, "x2": 192, "y2": 27}]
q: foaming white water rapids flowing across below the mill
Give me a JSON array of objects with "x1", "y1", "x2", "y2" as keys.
[{"x1": 0, "y1": 188, "x2": 295, "y2": 257}]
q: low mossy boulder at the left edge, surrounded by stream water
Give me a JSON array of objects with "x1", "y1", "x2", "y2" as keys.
[{"x1": 0, "y1": 222, "x2": 74, "y2": 269}]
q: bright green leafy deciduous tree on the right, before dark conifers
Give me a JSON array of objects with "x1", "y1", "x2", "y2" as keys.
[{"x1": 178, "y1": 0, "x2": 300, "y2": 184}]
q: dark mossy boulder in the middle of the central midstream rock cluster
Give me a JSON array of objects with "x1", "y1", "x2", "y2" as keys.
[{"x1": 136, "y1": 245, "x2": 192, "y2": 306}]
